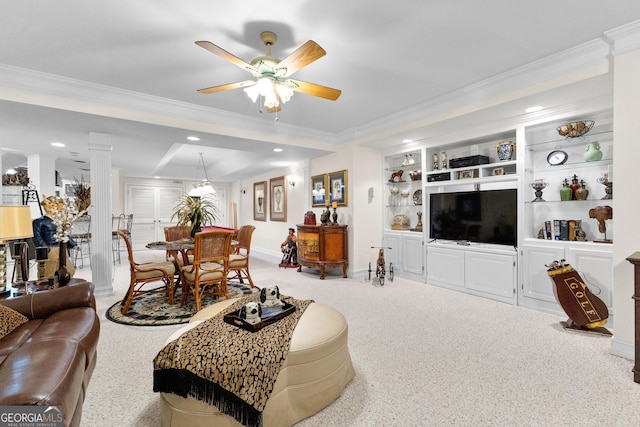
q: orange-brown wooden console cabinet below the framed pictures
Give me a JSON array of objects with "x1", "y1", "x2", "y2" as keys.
[{"x1": 297, "y1": 224, "x2": 349, "y2": 279}]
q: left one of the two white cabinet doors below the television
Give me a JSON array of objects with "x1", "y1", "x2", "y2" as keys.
[{"x1": 427, "y1": 247, "x2": 464, "y2": 288}]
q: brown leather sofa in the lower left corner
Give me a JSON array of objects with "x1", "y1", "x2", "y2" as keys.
[{"x1": 0, "y1": 279, "x2": 100, "y2": 426}]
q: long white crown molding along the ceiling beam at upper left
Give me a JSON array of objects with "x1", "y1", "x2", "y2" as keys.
[{"x1": 0, "y1": 64, "x2": 336, "y2": 151}]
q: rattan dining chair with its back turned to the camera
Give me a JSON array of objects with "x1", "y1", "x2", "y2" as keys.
[{"x1": 181, "y1": 230, "x2": 233, "y2": 312}]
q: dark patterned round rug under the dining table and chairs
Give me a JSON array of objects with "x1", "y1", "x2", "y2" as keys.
[{"x1": 106, "y1": 283, "x2": 258, "y2": 326}]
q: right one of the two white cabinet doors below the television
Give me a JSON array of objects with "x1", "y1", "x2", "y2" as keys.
[{"x1": 465, "y1": 251, "x2": 517, "y2": 304}]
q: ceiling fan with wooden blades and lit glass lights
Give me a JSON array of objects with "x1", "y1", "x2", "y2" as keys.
[{"x1": 196, "y1": 31, "x2": 342, "y2": 113}]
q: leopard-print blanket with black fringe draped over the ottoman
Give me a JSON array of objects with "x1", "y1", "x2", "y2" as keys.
[{"x1": 153, "y1": 292, "x2": 313, "y2": 426}]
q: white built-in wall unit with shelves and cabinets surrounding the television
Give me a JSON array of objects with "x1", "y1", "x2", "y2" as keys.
[{"x1": 383, "y1": 111, "x2": 613, "y2": 325}]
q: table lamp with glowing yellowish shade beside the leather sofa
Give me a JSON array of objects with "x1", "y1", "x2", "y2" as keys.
[{"x1": 0, "y1": 205, "x2": 33, "y2": 292}]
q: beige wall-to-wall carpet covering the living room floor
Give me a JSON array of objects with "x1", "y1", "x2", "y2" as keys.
[{"x1": 77, "y1": 254, "x2": 640, "y2": 427}]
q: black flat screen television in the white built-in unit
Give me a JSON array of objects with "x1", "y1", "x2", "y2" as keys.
[{"x1": 429, "y1": 189, "x2": 518, "y2": 246}]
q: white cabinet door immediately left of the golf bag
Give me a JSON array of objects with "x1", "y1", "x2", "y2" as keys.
[{"x1": 520, "y1": 245, "x2": 564, "y2": 310}]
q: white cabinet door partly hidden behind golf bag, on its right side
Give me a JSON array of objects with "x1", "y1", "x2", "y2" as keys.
[{"x1": 565, "y1": 247, "x2": 613, "y2": 312}]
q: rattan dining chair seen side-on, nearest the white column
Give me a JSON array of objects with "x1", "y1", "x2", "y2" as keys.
[{"x1": 118, "y1": 230, "x2": 176, "y2": 314}]
